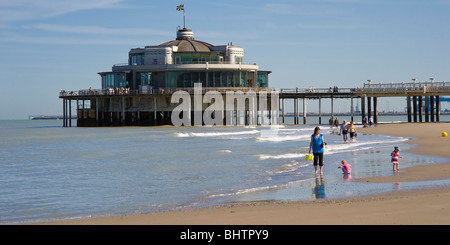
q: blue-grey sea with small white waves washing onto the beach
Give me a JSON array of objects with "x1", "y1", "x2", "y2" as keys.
[{"x1": 0, "y1": 115, "x2": 450, "y2": 225}]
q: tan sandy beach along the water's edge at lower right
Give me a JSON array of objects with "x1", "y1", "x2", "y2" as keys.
[{"x1": 36, "y1": 123, "x2": 450, "y2": 225}]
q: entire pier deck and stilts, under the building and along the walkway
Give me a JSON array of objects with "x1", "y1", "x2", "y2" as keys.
[{"x1": 60, "y1": 80, "x2": 450, "y2": 127}]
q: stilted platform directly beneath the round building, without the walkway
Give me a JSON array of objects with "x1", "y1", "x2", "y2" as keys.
[{"x1": 59, "y1": 86, "x2": 279, "y2": 127}]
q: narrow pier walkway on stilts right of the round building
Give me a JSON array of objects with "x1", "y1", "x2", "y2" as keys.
[{"x1": 279, "y1": 79, "x2": 450, "y2": 124}]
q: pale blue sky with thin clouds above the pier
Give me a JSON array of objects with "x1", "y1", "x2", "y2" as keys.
[{"x1": 0, "y1": 0, "x2": 450, "y2": 120}]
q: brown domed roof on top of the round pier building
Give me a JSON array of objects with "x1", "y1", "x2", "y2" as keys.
[{"x1": 159, "y1": 28, "x2": 213, "y2": 52}]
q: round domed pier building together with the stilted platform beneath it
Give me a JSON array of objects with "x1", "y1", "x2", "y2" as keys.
[{"x1": 60, "y1": 28, "x2": 278, "y2": 126}]
